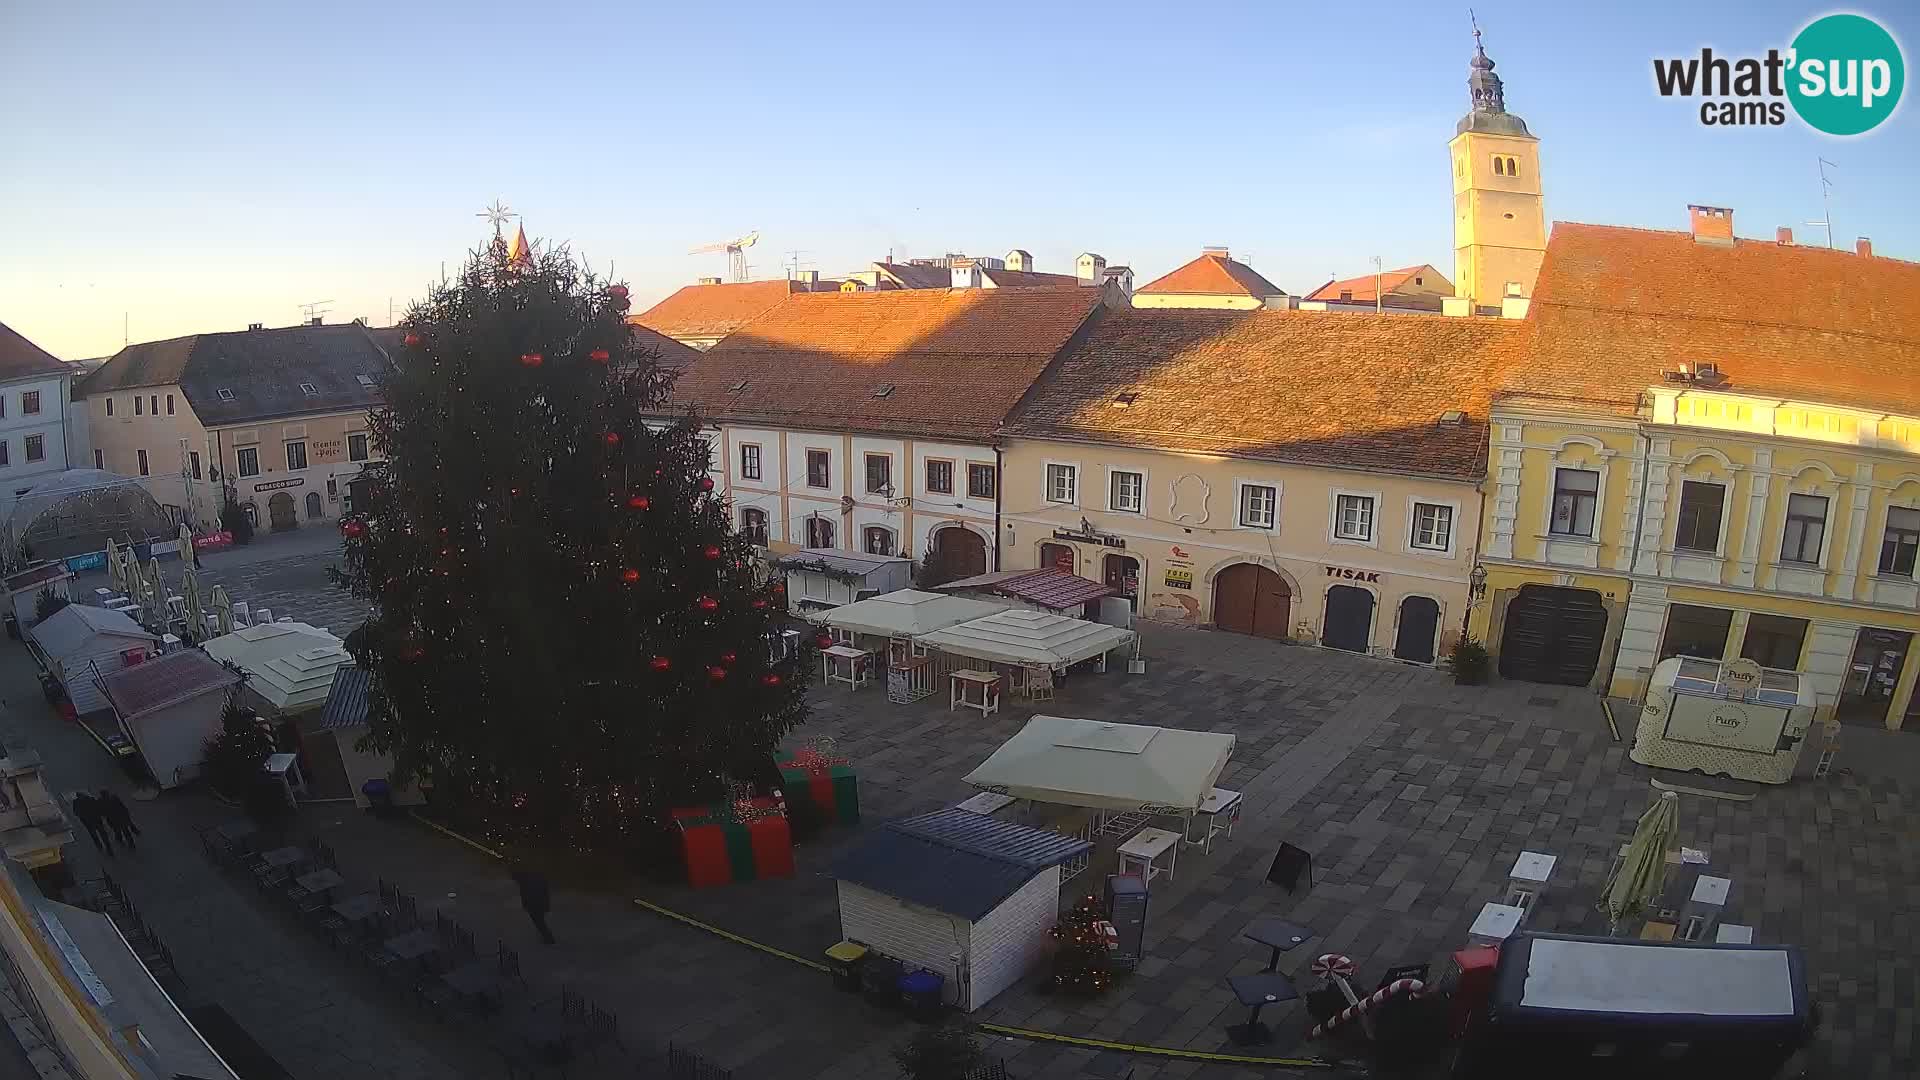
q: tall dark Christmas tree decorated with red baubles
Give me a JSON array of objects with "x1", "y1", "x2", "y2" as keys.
[{"x1": 338, "y1": 238, "x2": 810, "y2": 849}]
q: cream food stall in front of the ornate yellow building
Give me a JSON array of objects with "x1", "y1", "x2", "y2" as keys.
[{"x1": 1632, "y1": 657, "x2": 1814, "y2": 784}]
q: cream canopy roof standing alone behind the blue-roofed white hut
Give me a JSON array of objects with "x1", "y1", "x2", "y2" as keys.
[{"x1": 966, "y1": 717, "x2": 1233, "y2": 813}]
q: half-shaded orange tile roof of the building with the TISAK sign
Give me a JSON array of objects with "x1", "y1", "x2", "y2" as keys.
[{"x1": 1006, "y1": 309, "x2": 1528, "y2": 479}]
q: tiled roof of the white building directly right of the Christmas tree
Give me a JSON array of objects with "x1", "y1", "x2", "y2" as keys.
[{"x1": 674, "y1": 286, "x2": 1102, "y2": 440}]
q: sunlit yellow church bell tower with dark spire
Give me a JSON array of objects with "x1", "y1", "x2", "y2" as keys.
[{"x1": 1448, "y1": 27, "x2": 1548, "y2": 311}]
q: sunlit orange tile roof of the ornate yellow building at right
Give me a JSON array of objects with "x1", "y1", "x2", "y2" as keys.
[{"x1": 1501, "y1": 221, "x2": 1920, "y2": 415}]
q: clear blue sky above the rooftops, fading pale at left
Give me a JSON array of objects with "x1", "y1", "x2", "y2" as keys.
[{"x1": 0, "y1": 0, "x2": 1920, "y2": 359}]
